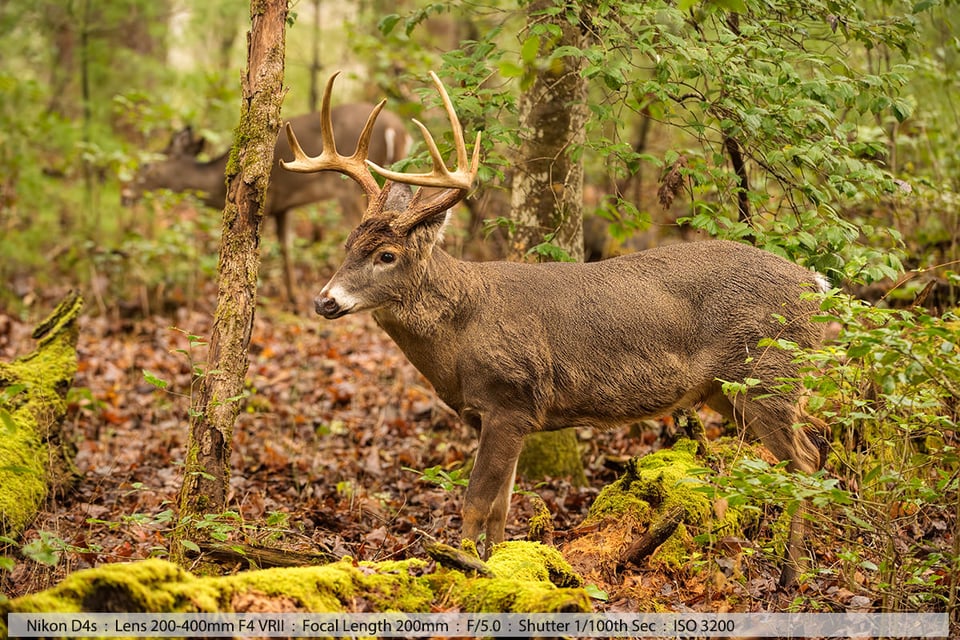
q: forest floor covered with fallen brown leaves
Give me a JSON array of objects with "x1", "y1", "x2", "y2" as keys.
[{"x1": 0, "y1": 268, "x2": 948, "y2": 612}]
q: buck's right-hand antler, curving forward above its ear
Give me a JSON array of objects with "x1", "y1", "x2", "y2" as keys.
[{"x1": 367, "y1": 71, "x2": 480, "y2": 192}]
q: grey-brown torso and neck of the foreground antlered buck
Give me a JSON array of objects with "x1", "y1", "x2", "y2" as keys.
[{"x1": 376, "y1": 241, "x2": 822, "y2": 440}]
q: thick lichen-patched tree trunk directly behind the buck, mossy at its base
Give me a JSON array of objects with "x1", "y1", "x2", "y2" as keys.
[{"x1": 510, "y1": 0, "x2": 588, "y2": 484}]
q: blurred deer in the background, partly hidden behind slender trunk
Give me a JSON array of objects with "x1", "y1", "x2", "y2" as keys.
[{"x1": 122, "y1": 102, "x2": 410, "y2": 303}]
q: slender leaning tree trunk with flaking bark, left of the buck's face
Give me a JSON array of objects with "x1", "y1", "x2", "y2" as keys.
[{"x1": 173, "y1": 0, "x2": 287, "y2": 558}]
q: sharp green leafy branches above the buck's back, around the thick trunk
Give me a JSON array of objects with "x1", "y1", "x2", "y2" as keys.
[{"x1": 380, "y1": 0, "x2": 944, "y2": 282}]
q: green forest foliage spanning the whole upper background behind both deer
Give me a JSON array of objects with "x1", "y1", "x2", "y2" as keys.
[{"x1": 0, "y1": 0, "x2": 960, "y2": 306}]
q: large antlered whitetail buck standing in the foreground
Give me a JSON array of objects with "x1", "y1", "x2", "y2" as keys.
[{"x1": 283, "y1": 74, "x2": 826, "y2": 583}]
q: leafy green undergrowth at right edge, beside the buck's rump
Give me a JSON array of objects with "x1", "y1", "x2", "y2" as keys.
[{"x1": 744, "y1": 290, "x2": 960, "y2": 611}]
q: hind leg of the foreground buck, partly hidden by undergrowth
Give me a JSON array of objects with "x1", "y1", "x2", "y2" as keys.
[{"x1": 707, "y1": 393, "x2": 826, "y2": 587}]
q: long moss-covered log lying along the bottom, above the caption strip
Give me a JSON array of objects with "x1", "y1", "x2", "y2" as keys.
[{"x1": 0, "y1": 542, "x2": 591, "y2": 636}]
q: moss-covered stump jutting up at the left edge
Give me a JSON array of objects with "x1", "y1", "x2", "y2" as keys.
[{"x1": 0, "y1": 292, "x2": 83, "y2": 537}]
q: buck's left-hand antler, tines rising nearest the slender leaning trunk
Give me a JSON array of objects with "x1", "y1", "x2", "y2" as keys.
[{"x1": 280, "y1": 71, "x2": 387, "y2": 198}]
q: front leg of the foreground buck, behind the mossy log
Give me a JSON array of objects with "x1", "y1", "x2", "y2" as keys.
[{"x1": 462, "y1": 420, "x2": 523, "y2": 557}]
